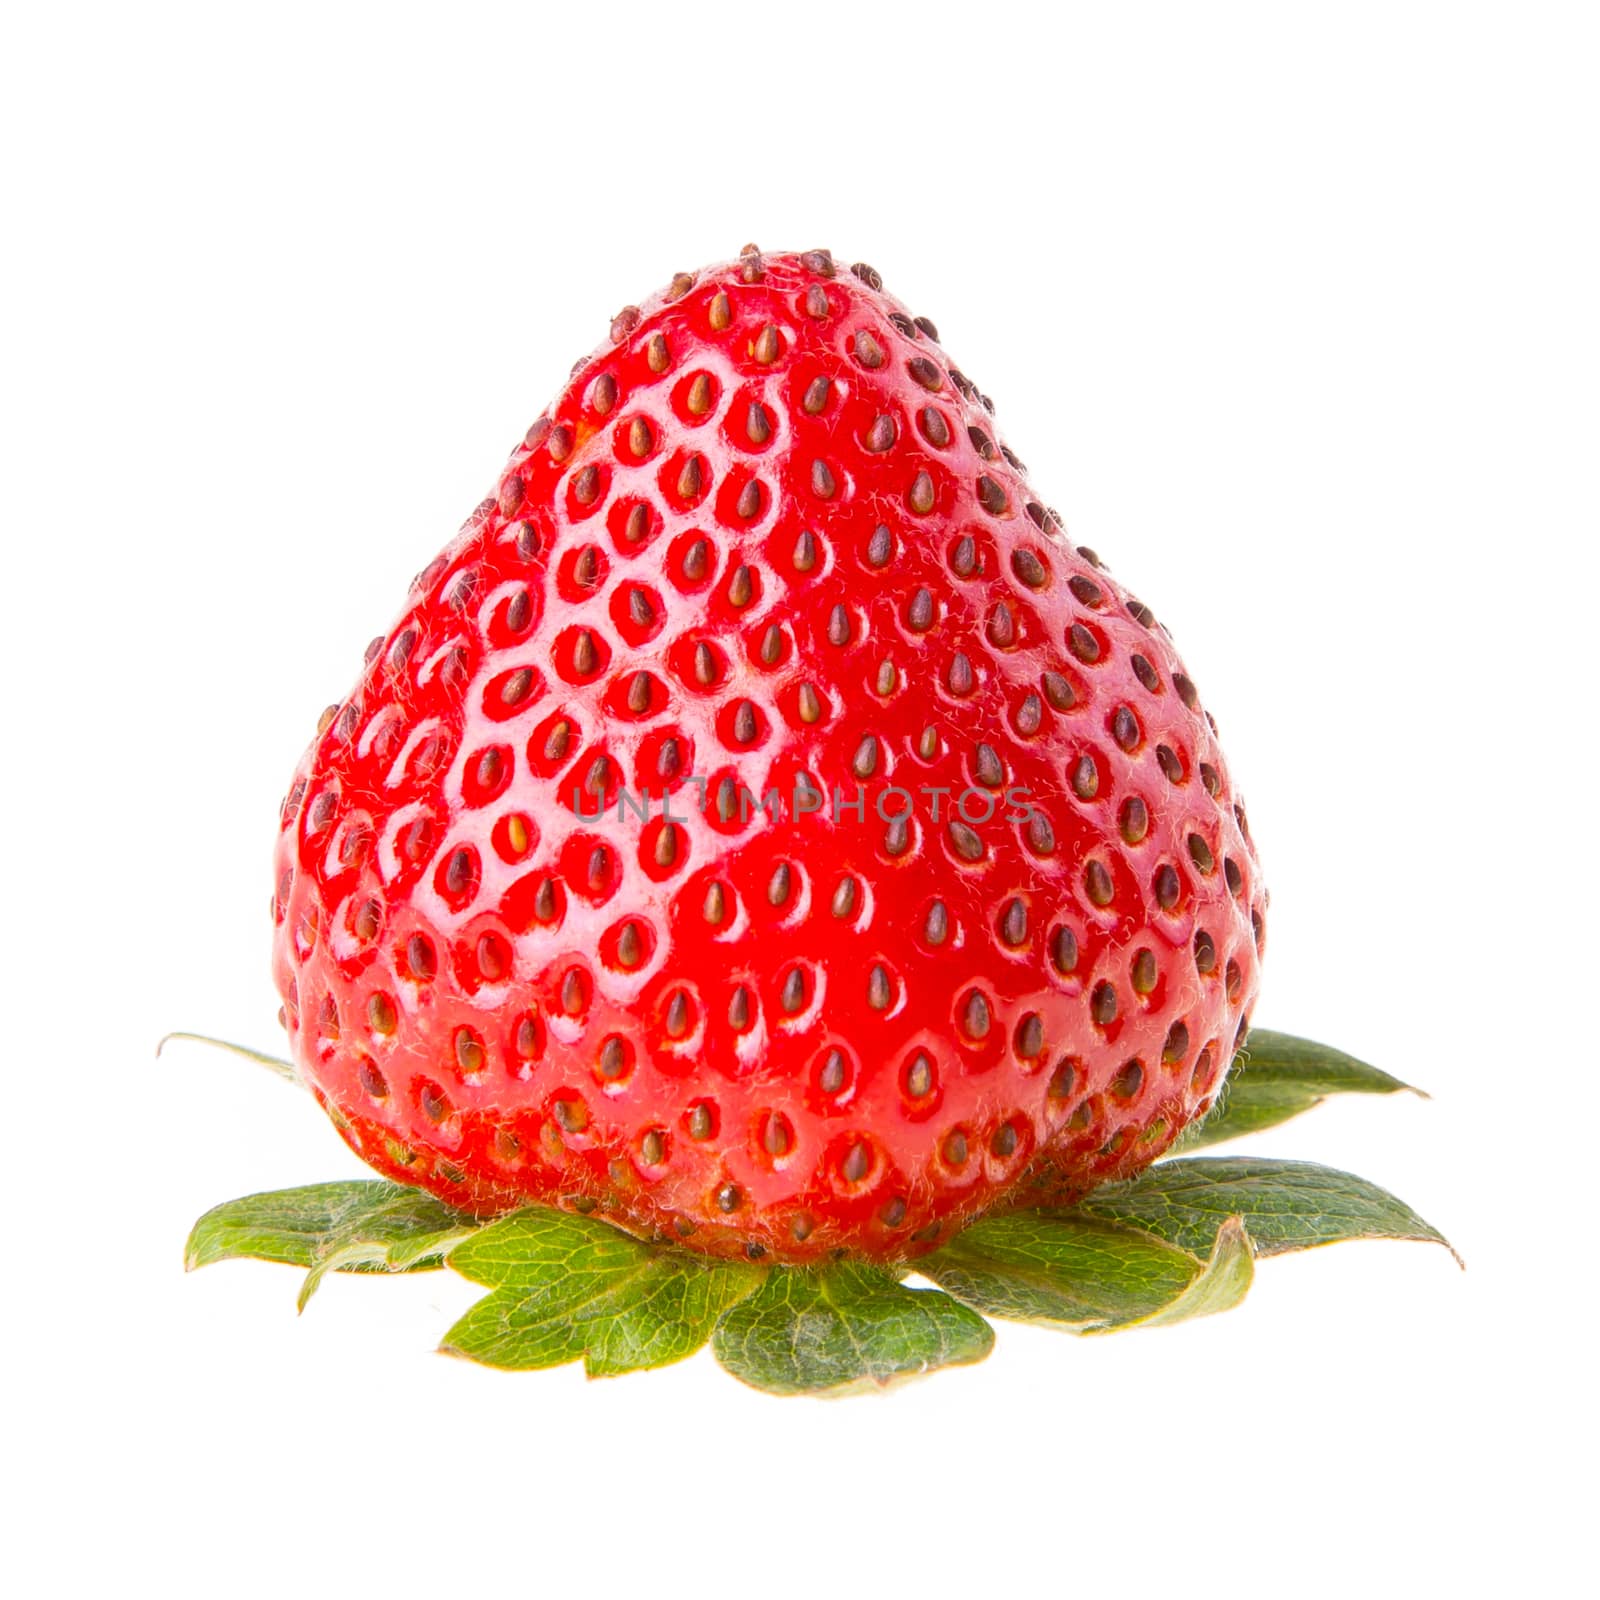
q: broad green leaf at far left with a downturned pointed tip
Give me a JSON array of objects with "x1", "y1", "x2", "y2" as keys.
[{"x1": 184, "y1": 1178, "x2": 478, "y2": 1309}]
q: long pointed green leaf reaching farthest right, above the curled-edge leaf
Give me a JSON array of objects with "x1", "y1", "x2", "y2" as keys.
[{"x1": 1075, "y1": 1155, "x2": 1459, "y2": 1261}]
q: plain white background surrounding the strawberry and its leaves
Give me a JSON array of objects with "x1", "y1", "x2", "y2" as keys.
[{"x1": 0, "y1": 3, "x2": 1600, "y2": 1597}]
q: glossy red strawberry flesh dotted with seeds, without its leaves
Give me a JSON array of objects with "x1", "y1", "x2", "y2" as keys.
[{"x1": 272, "y1": 250, "x2": 1266, "y2": 1259}]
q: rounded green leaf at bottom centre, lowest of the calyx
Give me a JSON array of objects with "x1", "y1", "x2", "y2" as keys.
[{"x1": 712, "y1": 1261, "x2": 994, "y2": 1395}]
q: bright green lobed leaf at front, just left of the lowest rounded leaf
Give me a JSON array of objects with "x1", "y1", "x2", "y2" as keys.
[{"x1": 442, "y1": 1206, "x2": 762, "y2": 1378}]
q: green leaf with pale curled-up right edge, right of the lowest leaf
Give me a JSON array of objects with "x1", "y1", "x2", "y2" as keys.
[{"x1": 917, "y1": 1211, "x2": 1251, "y2": 1333}]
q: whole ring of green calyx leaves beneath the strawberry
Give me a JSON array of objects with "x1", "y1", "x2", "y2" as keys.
[{"x1": 184, "y1": 1032, "x2": 1448, "y2": 1395}]
